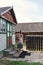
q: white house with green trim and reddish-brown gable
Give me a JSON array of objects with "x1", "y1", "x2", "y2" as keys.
[{"x1": 0, "y1": 7, "x2": 17, "y2": 51}]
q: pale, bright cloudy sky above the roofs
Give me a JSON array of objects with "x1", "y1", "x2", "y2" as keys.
[{"x1": 0, "y1": 0, "x2": 43, "y2": 23}]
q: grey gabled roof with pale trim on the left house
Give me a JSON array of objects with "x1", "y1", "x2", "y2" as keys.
[{"x1": 0, "y1": 6, "x2": 17, "y2": 23}]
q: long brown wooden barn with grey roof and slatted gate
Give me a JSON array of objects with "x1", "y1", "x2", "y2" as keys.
[{"x1": 15, "y1": 22, "x2": 43, "y2": 51}]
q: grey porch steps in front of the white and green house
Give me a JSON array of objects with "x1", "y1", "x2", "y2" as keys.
[{"x1": 3, "y1": 49, "x2": 22, "y2": 58}]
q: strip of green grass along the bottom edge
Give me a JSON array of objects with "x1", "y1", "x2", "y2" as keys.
[{"x1": 0, "y1": 60, "x2": 43, "y2": 65}]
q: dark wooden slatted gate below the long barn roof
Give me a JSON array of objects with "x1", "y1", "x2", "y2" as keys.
[{"x1": 26, "y1": 36, "x2": 43, "y2": 51}]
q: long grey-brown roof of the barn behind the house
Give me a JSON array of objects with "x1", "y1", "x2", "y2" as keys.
[{"x1": 15, "y1": 22, "x2": 43, "y2": 32}]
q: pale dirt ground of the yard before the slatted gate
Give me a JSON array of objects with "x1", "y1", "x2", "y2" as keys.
[{"x1": 2, "y1": 44, "x2": 43, "y2": 63}]
